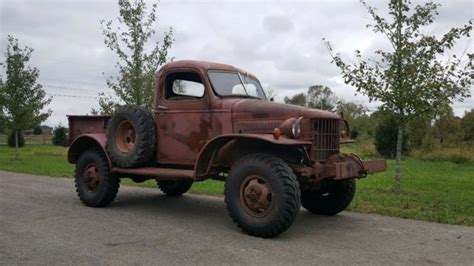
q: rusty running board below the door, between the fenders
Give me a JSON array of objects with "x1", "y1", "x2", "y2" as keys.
[{"x1": 112, "y1": 167, "x2": 194, "y2": 181}]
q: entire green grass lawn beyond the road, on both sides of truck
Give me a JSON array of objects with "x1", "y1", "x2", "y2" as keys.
[{"x1": 0, "y1": 145, "x2": 474, "y2": 226}]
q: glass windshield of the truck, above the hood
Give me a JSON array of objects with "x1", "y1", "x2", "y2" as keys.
[{"x1": 208, "y1": 71, "x2": 266, "y2": 100}]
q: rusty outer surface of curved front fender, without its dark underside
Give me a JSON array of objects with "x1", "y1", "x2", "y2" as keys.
[{"x1": 194, "y1": 134, "x2": 311, "y2": 180}]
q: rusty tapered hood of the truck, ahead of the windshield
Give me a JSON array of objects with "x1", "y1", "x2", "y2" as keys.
[{"x1": 232, "y1": 99, "x2": 340, "y2": 119}]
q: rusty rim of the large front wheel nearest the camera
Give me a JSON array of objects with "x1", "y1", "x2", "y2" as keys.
[{"x1": 240, "y1": 175, "x2": 274, "y2": 218}]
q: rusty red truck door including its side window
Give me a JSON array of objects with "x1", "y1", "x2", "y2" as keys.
[{"x1": 155, "y1": 69, "x2": 211, "y2": 166}]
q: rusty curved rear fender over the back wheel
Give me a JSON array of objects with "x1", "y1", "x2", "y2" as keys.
[{"x1": 67, "y1": 133, "x2": 112, "y2": 167}]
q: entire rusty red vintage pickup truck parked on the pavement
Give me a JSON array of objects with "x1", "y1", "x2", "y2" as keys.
[{"x1": 68, "y1": 60, "x2": 386, "y2": 237}]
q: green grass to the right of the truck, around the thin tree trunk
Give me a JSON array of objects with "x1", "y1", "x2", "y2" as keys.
[{"x1": 349, "y1": 159, "x2": 474, "y2": 226}]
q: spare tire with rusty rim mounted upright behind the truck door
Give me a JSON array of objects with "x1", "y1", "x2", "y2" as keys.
[{"x1": 107, "y1": 105, "x2": 156, "y2": 168}]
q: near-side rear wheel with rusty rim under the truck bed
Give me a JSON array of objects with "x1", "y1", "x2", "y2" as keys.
[{"x1": 74, "y1": 149, "x2": 120, "y2": 207}]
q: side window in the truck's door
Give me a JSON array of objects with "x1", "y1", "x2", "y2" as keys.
[{"x1": 165, "y1": 72, "x2": 205, "y2": 101}]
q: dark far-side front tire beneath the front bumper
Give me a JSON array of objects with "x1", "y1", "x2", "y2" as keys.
[{"x1": 301, "y1": 179, "x2": 356, "y2": 215}]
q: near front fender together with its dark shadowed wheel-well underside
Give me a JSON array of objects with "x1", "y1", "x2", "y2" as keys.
[{"x1": 194, "y1": 134, "x2": 311, "y2": 180}]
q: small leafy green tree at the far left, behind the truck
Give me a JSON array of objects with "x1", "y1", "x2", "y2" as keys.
[{"x1": 0, "y1": 35, "x2": 51, "y2": 159}]
